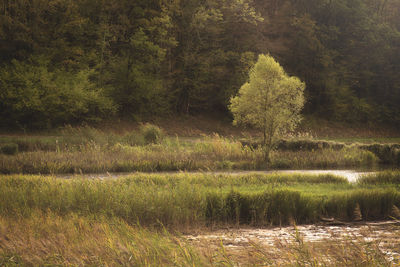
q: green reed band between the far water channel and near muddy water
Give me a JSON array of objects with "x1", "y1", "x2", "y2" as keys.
[{"x1": 0, "y1": 173, "x2": 400, "y2": 230}]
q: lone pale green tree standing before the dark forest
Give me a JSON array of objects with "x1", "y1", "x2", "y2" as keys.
[{"x1": 229, "y1": 55, "x2": 305, "y2": 159}]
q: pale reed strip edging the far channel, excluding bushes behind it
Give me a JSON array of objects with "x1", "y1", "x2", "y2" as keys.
[{"x1": 0, "y1": 135, "x2": 378, "y2": 174}]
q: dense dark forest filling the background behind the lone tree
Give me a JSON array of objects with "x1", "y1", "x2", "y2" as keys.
[{"x1": 0, "y1": 0, "x2": 400, "y2": 128}]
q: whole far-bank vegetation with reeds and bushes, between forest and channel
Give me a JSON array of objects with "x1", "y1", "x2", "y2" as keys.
[{"x1": 0, "y1": 125, "x2": 390, "y2": 174}]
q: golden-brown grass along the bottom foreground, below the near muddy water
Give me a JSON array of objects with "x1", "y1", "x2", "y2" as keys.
[{"x1": 0, "y1": 211, "x2": 400, "y2": 266}]
